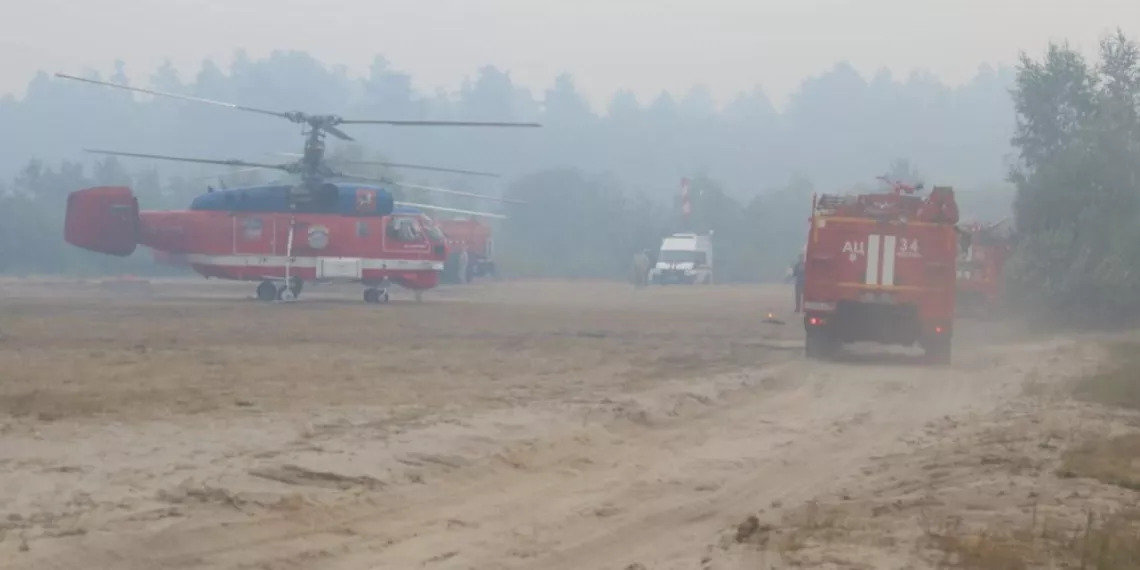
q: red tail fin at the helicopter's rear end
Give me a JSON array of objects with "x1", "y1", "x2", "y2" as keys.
[{"x1": 64, "y1": 186, "x2": 140, "y2": 258}]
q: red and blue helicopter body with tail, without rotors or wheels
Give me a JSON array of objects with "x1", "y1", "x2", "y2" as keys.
[{"x1": 66, "y1": 184, "x2": 447, "y2": 296}]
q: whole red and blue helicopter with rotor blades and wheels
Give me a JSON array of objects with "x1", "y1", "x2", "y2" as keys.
[{"x1": 56, "y1": 73, "x2": 540, "y2": 303}]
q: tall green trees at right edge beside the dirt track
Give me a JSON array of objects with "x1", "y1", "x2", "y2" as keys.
[{"x1": 1007, "y1": 32, "x2": 1140, "y2": 326}]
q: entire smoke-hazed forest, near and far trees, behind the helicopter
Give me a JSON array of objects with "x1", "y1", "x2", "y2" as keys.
[{"x1": 0, "y1": 51, "x2": 1015, "y2": 282}]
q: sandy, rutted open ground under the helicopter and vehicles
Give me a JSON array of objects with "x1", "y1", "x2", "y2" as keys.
[{"x1": 0, "y1": 279, "x2": 1127, "y2": 570}]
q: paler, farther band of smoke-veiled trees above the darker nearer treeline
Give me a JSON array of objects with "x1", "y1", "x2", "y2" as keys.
[{"x1": 0, "y1": 51, "x2": 1013, "y2": 190}]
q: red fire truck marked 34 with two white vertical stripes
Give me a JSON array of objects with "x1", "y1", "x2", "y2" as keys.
[{"x1": 804, "y1": 177, "x2": 959, "y2": 363}]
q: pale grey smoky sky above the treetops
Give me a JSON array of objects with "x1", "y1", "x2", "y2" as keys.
[{"x1": 0, "y1": 0, "x2": 1140, "y2": 109}]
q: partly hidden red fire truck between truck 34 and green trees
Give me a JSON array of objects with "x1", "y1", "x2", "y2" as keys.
[{"x1": 958, "y1": 219, "x2": 1012, "y2": 316}]
